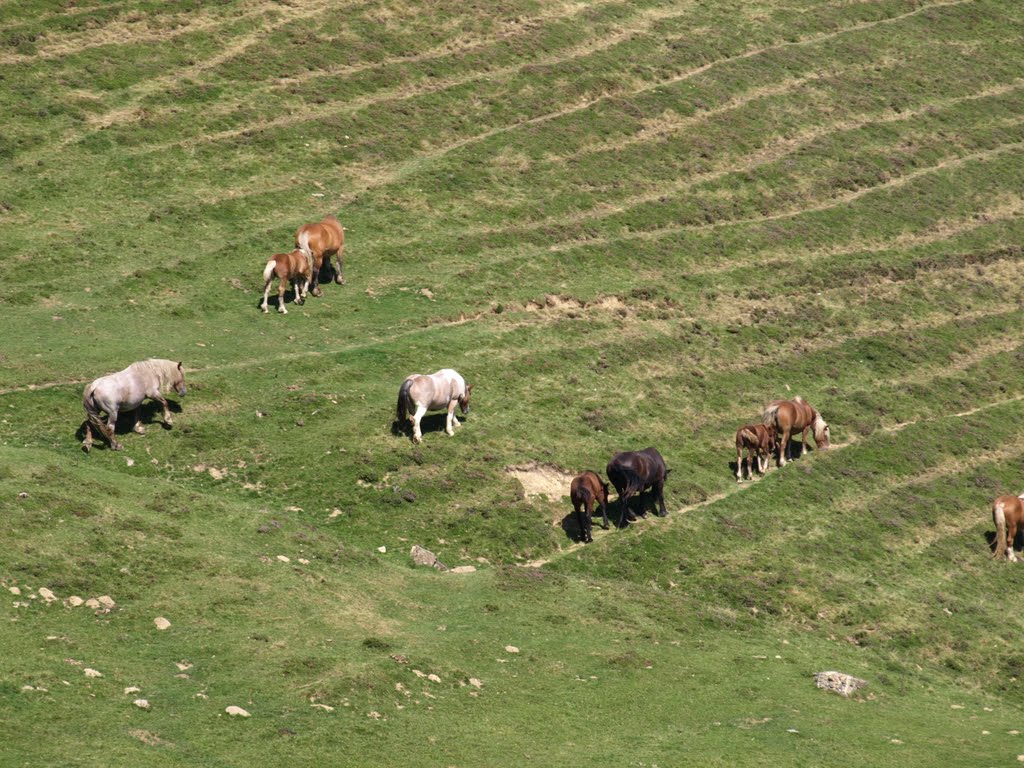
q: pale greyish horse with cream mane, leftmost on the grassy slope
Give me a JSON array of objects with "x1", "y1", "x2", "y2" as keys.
[{"x1": 82, "y1": 357, "x2": 185, "y2": 453}]
